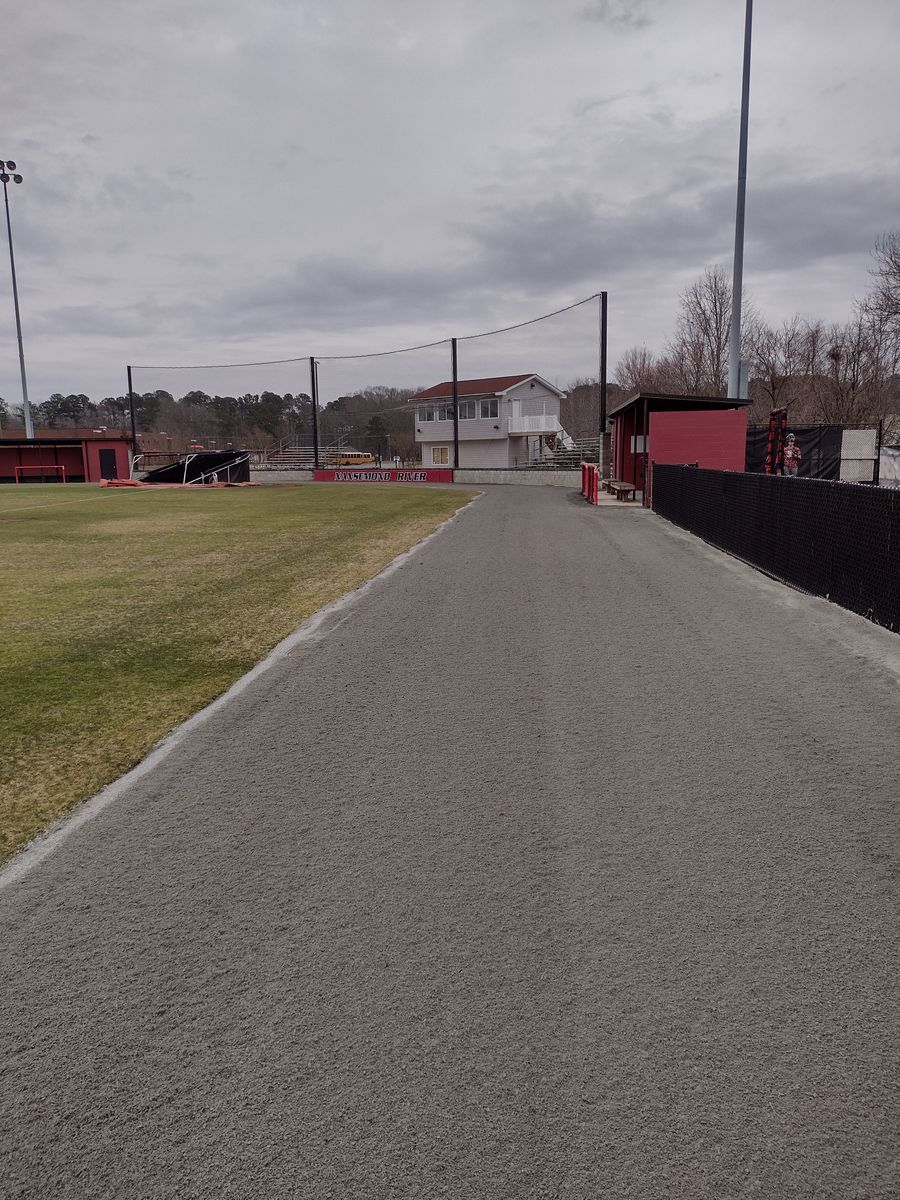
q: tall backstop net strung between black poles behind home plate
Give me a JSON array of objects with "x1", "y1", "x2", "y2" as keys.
[{"x1": 130, "y1": 296, "x2": 607, "y2": 473}]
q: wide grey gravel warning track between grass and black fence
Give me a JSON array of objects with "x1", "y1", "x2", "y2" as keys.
[{"x1": 0, "y1": 487, "x2": 900, "y2": 1200}]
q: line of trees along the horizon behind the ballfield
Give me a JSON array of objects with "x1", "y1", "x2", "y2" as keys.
[{"x1": 0, "y1": 232, "x2": 900, "y2": 446}]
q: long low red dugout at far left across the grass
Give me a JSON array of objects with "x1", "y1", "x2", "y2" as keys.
[{"x1": 0, "y1": 430, "x2": 131, "y2": 484}]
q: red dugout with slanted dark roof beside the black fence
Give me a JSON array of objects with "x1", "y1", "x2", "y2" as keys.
[{"x1": 610, "y1": 392, "x2": 749, "y2": 504}]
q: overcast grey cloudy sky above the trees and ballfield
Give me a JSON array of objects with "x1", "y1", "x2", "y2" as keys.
[{"x1": 0, "y1": 0, "x2": 900, "y2": 403}]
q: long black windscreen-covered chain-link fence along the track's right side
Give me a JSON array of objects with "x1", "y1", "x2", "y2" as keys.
[{"x1": 653, "y1": 463, "x2": 900, "y2": 630}]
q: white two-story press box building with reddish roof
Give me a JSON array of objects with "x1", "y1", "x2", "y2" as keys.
[{"x1": 412, "y1": 374, "x2": 571, "y2": 468}]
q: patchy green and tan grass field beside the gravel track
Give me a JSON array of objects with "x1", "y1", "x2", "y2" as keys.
[{"x1": 0, "y1": 484, "x2": 472, "y2": 859}]
